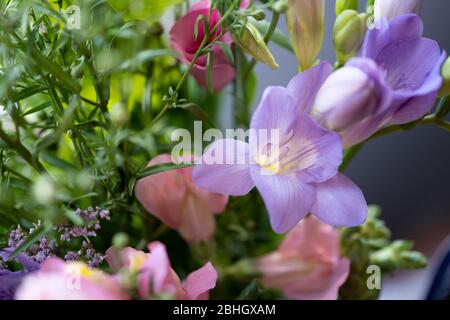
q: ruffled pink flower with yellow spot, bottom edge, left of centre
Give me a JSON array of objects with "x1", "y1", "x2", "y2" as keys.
[{"x1": 106, "y1": 242, "x2": 217, "y2": 300}]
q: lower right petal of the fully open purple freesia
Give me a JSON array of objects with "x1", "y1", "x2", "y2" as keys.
[{"x1": 312, "y1": 173, "x2": 368, "y2": 226}]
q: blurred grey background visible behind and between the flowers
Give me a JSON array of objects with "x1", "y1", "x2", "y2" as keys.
[{"x1": 255, "y1": 0, "x2": 450, "y2": 299}]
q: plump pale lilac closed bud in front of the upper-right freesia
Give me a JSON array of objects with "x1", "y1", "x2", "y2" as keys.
[{"x1": 312, "y1": 66, "x2": 378, "y2": 131}]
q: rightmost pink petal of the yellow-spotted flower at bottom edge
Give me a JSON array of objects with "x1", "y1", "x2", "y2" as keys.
[{"x1": 184, "y1": 262, "x2": 217, "y2": 300}]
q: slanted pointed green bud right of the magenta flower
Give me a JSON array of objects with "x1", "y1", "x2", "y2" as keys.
[{"x1": 232, "y1": 18, "x2": 278, "y2": 69}]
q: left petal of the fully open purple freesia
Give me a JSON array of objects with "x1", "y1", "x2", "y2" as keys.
[{"x1": 192, "y1": 139, "x2": 254, "y2": 196}]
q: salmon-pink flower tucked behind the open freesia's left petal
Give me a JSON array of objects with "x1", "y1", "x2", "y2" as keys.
[{"x1": 135, "y1": 154, "x2": 228, "y2": 243}]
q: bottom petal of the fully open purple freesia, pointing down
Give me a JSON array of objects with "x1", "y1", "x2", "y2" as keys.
[{"x1": 250, "y1": 165, "x2": 315, "y2": 233}]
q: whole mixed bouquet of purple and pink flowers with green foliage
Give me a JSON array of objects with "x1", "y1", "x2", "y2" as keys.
[{"x1": 0, "y1": 0, "x2": 450, "y2": 300}]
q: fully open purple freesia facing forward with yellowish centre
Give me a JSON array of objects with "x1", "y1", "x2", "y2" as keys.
[{"x1": 193, "y1": 63, "x2": 367, "y2": 233}]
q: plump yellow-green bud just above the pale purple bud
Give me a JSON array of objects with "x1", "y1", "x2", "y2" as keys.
[{"x1": 333, "y1": 10, "x2": 367, "y2": 64}]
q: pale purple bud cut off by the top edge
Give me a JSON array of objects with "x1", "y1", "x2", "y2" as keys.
[{"x1": 374, "y1": 0, "x2": 422, "y2": 20}]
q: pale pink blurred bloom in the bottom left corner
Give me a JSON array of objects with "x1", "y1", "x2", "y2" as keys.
[{"x1": 16, "y1": 258, "x2": 129, "y2": 300}]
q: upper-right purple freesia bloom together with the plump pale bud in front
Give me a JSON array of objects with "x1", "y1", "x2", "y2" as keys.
[{"x1": 312, "y1": 14, "x2": 446, "y2": 147}]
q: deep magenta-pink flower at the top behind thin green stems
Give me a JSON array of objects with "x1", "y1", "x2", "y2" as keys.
[{"x1": 170, "y1": 0, "x2": 249, "y2": 91}]
